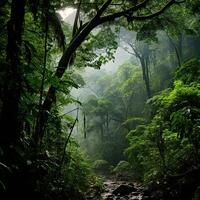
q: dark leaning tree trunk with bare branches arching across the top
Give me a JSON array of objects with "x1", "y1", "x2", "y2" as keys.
[{"x1": 36, "y1": 0, "x2": 176, "y2": 147}]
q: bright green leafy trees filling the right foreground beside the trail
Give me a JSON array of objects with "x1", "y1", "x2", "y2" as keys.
[{"x1": 125, "y1": 57, "x2": 199, "y2": 199}]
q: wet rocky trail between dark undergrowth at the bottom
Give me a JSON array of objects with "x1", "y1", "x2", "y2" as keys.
[{"x1": 86, "y1": 180, "x2": 143, "y2": 200}]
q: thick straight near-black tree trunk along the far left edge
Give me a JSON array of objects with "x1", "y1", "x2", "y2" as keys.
[{"x1": 0, "y1": 0, "x2": 26, "y2": 146}]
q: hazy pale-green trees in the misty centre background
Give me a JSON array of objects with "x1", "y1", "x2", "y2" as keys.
[{"x1": 80, "y1": 61, "x2": 145, "y2": 164}]
